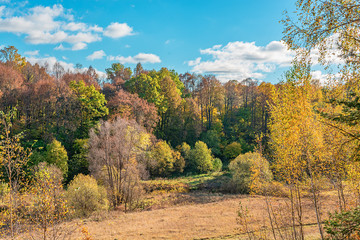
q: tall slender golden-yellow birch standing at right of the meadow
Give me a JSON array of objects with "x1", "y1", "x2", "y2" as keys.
[{"x1": 270, "y1": 63, "x2": 324, "y2": 238}]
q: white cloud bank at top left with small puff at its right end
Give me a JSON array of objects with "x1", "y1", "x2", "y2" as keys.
[{"x1": 0, "y1": 4, "x2": 134, "y2": 51}]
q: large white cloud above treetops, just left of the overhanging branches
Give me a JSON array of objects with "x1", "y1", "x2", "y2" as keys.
[{"x1": 187, "y1": 41, "x2": 294, "y2": 81}]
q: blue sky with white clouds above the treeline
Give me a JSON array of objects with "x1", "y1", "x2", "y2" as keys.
[{"x1": 0, "y1": 0, "x2": 302, "y2": 83}]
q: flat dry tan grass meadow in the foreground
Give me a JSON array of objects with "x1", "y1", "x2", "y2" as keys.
[{"x1": 54, "y1": 192, "x2": 336, "y2": 239}]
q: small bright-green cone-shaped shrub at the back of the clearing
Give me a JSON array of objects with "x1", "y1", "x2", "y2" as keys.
[{"x1": 188, "y1": 141, "x2": 214, "y2": 173}]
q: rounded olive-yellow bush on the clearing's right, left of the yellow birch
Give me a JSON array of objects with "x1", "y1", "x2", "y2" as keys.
[{"x1": 229, "y1": 152, "x2": 272, "y2": 194}]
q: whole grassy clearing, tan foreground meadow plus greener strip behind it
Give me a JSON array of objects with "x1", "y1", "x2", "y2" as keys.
[{"x1": 14, "y1": 173, "x2": 344, "y2": 240}]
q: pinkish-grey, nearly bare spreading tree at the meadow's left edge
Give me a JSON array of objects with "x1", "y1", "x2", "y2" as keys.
[{"x1": 89, "y1": 118, "x2": 149, "y2": 209}]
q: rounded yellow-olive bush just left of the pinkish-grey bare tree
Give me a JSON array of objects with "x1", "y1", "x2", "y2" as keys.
[{"x1": 66, "y1": 174, "x2": 108, "y2": 217}]
